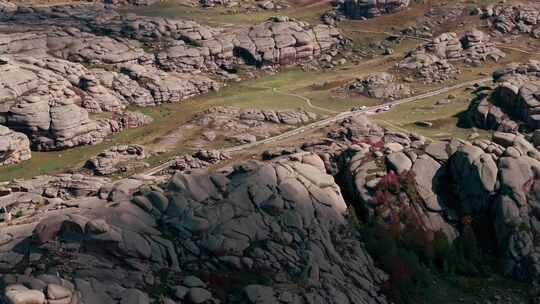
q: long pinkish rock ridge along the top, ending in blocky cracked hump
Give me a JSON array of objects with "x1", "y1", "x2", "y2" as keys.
[{"x1": 0, "y1": 5, "x2": 345, "y2": 73}]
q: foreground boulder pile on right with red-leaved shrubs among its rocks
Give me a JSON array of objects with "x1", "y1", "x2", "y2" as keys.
[{"x1": 312, "y1": 117, "x2": 540, "y2": 282}]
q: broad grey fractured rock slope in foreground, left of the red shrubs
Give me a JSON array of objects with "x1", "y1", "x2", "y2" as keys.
[{"x1": 0, "y1": 153, "x2": 387, "y2": 304}]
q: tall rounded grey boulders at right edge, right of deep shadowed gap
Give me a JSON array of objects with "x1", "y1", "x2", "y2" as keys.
[{"x1": 450, "y1": 133, "x2": 540, "y2": 281}]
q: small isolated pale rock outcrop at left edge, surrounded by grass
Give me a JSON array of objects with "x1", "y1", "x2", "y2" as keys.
[{"x1": 0, "y1": 125, "x2": 32, "y2": 166}]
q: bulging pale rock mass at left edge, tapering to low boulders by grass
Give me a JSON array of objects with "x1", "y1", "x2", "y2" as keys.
[{"x1": 0, "y1": 57, "x2": 154, "y2": 150}]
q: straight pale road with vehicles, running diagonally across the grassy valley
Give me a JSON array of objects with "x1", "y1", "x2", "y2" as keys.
[{"x1": 143, "y1": 77, "x2": 492, "y2": 175}]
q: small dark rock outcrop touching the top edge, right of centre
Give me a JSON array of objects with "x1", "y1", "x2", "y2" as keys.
[{"x1": 342, "y1": 0, "x2": 410, "y2": 19}]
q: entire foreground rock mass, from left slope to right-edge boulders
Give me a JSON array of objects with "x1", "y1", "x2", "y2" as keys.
[{"x1": 5, "y1": 116, "x2": 540, "y2": 304}]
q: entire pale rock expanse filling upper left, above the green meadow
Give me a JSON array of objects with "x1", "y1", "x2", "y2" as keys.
[{"x1": 0, "y1": 4, "x2": 345, "y2": 163}]
